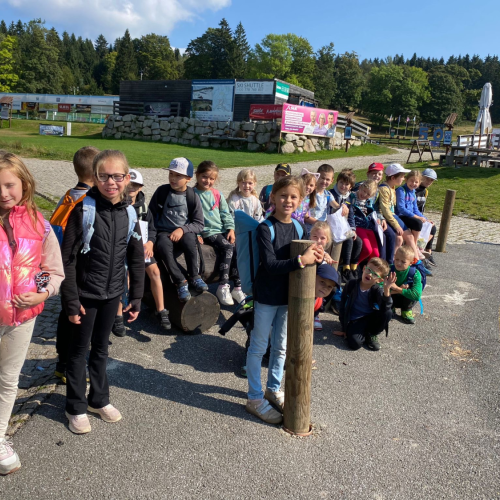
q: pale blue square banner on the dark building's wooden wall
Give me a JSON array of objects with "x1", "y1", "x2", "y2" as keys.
[{"x1": 191, "y1": 80, "x2": 235, "y2": 121}]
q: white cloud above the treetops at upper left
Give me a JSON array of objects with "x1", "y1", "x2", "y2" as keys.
[{"x1": 4, "y1": 0, "x2": 231, "y2": 42}]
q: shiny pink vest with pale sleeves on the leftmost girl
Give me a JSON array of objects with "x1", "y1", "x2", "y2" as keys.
[{"x1": 0, "y1": 206, "x2": 64, "y2": 326}]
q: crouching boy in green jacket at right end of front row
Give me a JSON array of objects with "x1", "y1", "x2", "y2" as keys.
[{"x1": 391, "y1": 245, "x2": 422, "y2": 325}]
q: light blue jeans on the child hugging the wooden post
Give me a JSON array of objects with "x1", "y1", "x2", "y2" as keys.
[{"x1": 247, "y1": 302, "x2": 288, "y2": 399}]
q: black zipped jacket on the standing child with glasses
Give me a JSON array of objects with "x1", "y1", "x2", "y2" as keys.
[{"x1": 61, "y1": 187, "x2": 145, "y2": 316}]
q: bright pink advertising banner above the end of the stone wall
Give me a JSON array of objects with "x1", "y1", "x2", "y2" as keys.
[{"x1": 281, "y1": 104, "x2": 339, "y2": 137}]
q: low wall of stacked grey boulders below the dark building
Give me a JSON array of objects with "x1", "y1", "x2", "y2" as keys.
[{"x1": 102, "y1": 115, "x2": 361, "y2": 153}]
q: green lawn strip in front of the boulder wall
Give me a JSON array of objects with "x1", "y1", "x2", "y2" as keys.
[{"x1": 0, "y1": 120, "x2": 394, "y2": 168}]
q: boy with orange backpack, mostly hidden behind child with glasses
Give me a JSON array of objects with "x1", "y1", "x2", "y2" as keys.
[{"x1": 51, "y1": 146, "x2": 99, "y2": 384}]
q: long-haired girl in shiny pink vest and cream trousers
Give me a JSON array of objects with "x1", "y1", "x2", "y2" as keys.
[{"x1": 0, "y1": 153, "x2": 64, "y2": 475}]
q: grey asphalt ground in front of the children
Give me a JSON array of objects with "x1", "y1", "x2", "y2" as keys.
[{"x1": 0, "y1": 244, "x2": 500, "y2": 500}]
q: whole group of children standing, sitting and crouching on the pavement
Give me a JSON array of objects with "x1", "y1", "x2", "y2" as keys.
[{"x1": 0, "y1": 147, "x2": 436, "y2": 474}]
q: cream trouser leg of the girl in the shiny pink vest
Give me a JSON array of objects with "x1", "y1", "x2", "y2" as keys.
[{"x1": 0, "y1": 319, "x2": 35, "y2": 439}]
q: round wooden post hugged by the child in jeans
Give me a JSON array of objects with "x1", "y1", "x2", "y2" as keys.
[{"x1": 283, "y1": 240, "x2": 316, "y2": 435}]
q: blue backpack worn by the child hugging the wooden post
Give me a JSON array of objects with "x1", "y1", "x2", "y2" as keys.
[{"x1": 234, "y1": 210, "x2": 304, "y2": 295}]
